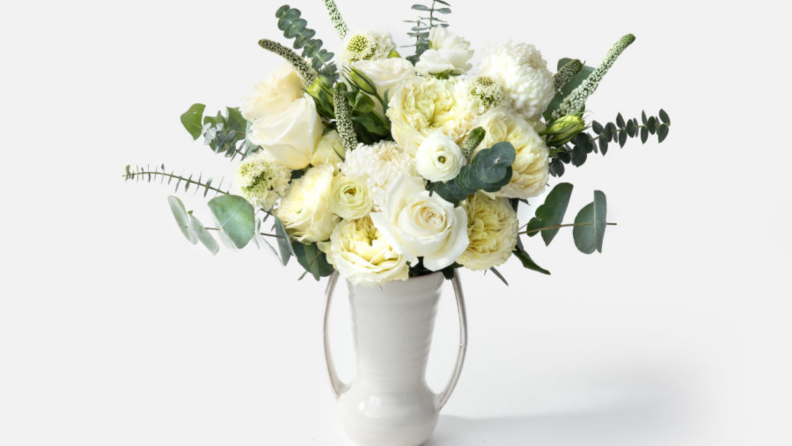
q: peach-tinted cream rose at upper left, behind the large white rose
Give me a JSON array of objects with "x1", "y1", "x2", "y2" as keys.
[{"x1": 239, "y1": 63, "x2": 303, "y2": 122}]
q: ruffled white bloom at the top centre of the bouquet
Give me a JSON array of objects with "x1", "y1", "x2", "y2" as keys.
[{"x1": 415, "y1": 27, "x2": 474, "y2": 76}]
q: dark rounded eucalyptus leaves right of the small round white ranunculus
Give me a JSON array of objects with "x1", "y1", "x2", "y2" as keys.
[{"x1": 429, "y1": 142, "x2": 516, "y2": 206}]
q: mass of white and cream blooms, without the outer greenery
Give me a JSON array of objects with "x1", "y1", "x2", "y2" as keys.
[{"x1": 232, "y1": 27, "x2": 554, "y2": 286}]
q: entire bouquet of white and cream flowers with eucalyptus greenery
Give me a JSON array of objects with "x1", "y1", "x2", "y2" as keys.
[{"x1": 126, "y1": 0, "x2": 670, "y2": 445}]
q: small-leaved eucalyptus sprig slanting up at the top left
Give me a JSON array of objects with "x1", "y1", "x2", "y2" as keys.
[{"x1": 275, "y1": 5, "x2": 338, "y2": 83}]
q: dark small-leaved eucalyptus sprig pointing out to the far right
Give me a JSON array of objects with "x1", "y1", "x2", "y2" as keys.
[{"x1": 550, "y1": 110, "x2": 671, "y2": 177}]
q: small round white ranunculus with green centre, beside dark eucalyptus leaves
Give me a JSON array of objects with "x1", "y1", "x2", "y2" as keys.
[{"x1": 415, "y1": 131, "x2": 467, "y2": 182}]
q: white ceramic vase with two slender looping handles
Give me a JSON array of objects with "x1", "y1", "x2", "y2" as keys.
[{"x1": 325, "y1": 273, "x2": 467, "y2": 446}]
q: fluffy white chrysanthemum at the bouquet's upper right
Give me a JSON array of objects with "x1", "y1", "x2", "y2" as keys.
[{"x1": 479, "y1": 42, "x2": 555, "y2": 120}]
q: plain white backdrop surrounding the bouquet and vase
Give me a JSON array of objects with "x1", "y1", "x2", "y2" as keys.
[{"x1": 0, "y1": 0, "x2": 792, "y2": 446}]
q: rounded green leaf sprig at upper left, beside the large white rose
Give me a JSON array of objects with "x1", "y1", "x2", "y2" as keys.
[{"x1": 181, "y1": 104, "x2": 258, "y2": 159}]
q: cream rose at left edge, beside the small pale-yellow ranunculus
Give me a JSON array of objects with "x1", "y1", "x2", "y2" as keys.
[{"x1": 275, "y1": 164, "x2": 340, "y2": 243}]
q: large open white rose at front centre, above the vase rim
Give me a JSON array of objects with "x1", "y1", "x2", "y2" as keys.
[{"x1": 371, "y1": 175, "x2": 469, "y2": 271}]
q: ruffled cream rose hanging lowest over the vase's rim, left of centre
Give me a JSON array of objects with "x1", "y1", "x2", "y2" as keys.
[{"x1": 319, "y1": 217, "x2": 410, "y2": 286}]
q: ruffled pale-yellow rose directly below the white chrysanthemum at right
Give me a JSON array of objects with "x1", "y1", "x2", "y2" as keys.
[{"x1": 475, "y1": 108, "x2": 550, "y2": 199}]
